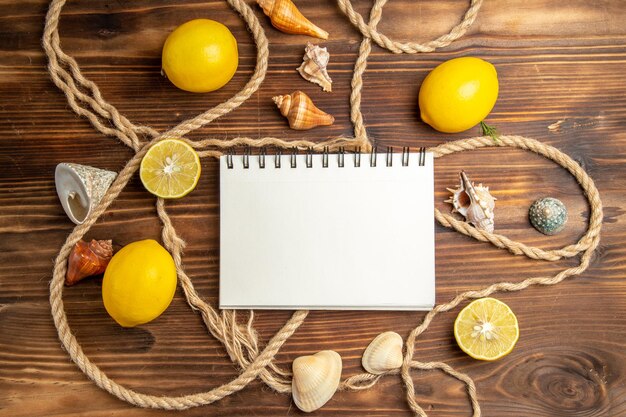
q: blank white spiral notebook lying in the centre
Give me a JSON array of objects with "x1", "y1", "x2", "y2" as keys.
[{"x1": 219, "y1": 149, "x2": 435, "y2": 310}]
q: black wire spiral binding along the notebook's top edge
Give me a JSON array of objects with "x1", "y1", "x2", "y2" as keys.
[{"x1": 226, "y1": 146, "x2": 426, "y2": 169}]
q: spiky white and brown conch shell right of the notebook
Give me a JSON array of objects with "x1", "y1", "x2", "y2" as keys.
[{"x1": 445, "y1": 171, "x2": 496, "y2": 233}]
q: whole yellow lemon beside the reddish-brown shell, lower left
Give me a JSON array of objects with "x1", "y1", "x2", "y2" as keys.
[{"x1": 102, "y1": 239, "x2": 176, "y2": 327}]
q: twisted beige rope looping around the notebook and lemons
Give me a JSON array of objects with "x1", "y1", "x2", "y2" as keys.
[{"x1": 43, "y1": 0, "x2": 602, "y2": 417}]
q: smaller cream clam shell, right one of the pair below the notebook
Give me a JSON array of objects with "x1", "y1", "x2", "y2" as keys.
[{"x1": 361, "y1": 332, "x2": 403, "y2": 375}]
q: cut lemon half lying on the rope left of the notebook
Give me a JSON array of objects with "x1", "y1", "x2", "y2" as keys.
[{"x1": 139, "y1": 139, "x2": 200, "y2": 198}]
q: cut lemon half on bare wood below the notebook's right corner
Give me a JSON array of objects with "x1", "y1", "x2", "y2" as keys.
[{"x1": 454, "y1": 298, "x2": 519, "y2": 361}]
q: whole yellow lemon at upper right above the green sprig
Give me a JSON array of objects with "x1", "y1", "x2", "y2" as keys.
[{"x1": 419, "y1": 57, "x2": 498, "y2": 133}]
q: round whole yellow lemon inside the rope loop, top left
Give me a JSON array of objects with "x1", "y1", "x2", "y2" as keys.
[{"x1": 161, "y1": 19, "x2": 239, "y2": 93}]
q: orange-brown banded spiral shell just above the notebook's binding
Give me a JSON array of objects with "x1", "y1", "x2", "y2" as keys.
[{"x1": 272, "y1": 91, "x2": 335, "y2": 130}]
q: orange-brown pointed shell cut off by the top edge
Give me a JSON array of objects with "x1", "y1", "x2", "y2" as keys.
[{"x1": 257, "y1": 0, "x2": 328, "y2": 39}]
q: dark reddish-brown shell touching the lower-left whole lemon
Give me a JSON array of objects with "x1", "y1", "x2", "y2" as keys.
[{"x1": 65, "y1": 240, "x2": 113, "y2": 285}]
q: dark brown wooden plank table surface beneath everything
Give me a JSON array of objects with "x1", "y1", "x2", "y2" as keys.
[{"x1": 0, "y1": 0, "x2": 626, "y2": 417}]
